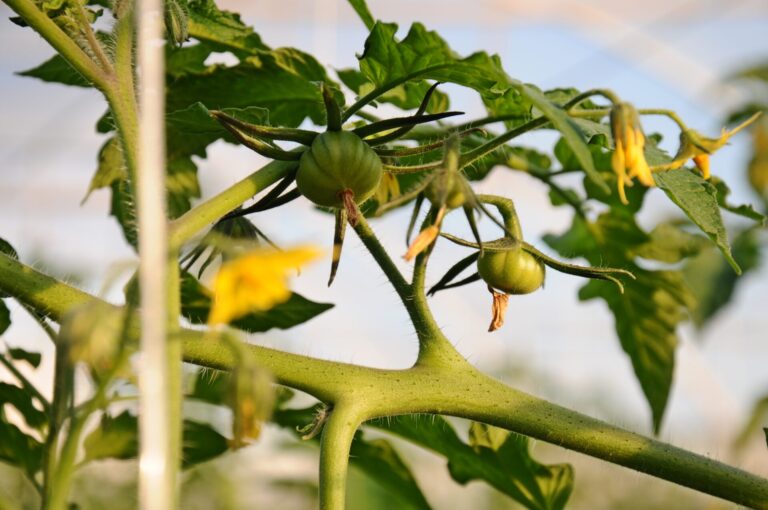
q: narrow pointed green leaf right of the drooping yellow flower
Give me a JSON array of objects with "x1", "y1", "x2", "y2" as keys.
[{"x1": 653, "y1": 168, "x2": 741, "y2": 274}]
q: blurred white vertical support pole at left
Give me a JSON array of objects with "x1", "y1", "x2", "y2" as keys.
[{"x1": 136, "y1": 0, "x2": 172, "y2": 510}]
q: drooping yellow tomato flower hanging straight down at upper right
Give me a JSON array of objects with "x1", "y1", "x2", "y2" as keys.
[{"x1": 611, "y1": 103, "x2": 654, "y2": 204}]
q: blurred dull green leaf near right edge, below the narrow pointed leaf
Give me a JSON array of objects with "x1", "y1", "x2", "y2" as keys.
[{"x1": 683, "y1": 229, "x2": 762, "y2": 329}]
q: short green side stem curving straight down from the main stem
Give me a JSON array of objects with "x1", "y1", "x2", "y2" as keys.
[{"x1": 320, "y1": 401, "x2": 363, "y2": 510}]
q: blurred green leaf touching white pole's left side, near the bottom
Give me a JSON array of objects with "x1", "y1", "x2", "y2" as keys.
[{"x1": 83, "y1": 411, "x2": 139, "y2": 462}]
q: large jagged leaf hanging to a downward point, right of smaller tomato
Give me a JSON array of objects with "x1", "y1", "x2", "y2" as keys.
[{"x1": 544, "y1": 208, "x2": 695, "y2": 432}]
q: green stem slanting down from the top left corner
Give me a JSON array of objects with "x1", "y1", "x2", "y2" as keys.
[{"x1": 4, "y1": 0, "x2": 110, "y2": 91}]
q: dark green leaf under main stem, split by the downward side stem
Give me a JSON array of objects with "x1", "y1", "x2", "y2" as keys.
[{"x1": 273, "y1": 407, "x2": 431, "y2": 510}]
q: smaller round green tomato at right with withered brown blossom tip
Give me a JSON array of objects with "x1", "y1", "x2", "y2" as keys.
[{"x1": 477, "y1": 248, "x2": 544, "y2": 294}]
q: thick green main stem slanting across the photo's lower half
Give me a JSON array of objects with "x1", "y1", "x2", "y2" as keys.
[{"x1": 0, "y1": 254, "x2": 768, "y2": 509}]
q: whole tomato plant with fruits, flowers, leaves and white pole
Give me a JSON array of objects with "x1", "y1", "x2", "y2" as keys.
[{"x1": 0, "y1": 0, "x2": 768, "y2": 509}]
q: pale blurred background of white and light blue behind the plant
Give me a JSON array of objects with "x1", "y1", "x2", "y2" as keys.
[{"x1": 0, "y1": 0, "x2": 768, "y2": 509}]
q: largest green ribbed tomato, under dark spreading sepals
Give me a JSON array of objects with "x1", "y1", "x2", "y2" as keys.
[{"x1": 296, "y1": 131, "x2": 382, "y2": 208}]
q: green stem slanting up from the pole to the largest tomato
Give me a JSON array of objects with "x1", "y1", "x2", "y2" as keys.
[{"x1": 170, "y1": 161, "x2": 296, "y2": 249}]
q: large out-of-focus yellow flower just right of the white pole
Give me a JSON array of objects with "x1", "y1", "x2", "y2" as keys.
[{"x1": 208, "y1": 247, "x2": 319, "y2": 325}]
